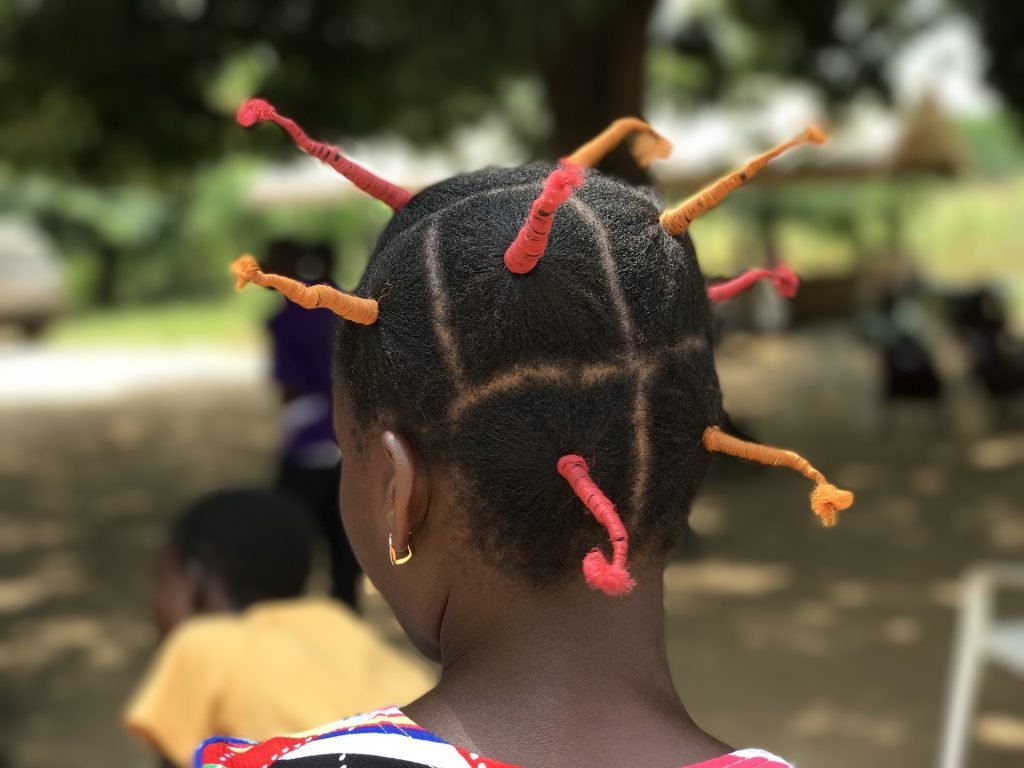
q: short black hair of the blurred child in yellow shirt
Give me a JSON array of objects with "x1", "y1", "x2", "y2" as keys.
[{"x1": 170, "y1": 489, "x2": 313, "y2": 608}]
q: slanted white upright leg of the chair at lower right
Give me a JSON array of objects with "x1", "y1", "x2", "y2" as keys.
[{"x1": 938, "y1": 568, "x2": 992, "y2": 768}]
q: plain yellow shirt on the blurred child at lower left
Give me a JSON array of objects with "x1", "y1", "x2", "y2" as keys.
[{"x1": 125, "y1": 599, "x2": 434, "y2": 767}]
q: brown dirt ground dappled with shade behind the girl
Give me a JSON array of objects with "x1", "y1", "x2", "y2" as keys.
[{"x1": 0, "y1": 332, "x2": 1024, "y2": 768}]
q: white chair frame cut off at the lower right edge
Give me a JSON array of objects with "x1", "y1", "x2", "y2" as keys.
[{"x1": 938, "y1": 563, "x2": 1024, "y2": 768}]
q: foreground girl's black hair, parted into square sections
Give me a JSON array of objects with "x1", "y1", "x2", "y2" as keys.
[{"x1": 336, "y1": 165, "x2": 721, "y2": 586}]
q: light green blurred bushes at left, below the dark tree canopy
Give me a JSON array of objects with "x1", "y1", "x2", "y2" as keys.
[{"x1": 0, "y1": 158, "x2": 388, "y2": 306}]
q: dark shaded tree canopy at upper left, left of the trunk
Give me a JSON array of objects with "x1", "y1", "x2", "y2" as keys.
[{"x1": 0, "y1": 0, "x2": 622, "y2": 182}]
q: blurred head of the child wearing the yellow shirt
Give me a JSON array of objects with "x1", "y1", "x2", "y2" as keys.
[{"x1": 153, "y1": 489, "x2": 312, "y2": 636}]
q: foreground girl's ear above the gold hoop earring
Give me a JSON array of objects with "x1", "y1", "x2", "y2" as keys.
[{"x1": 381, "y1": 430, "x2": 430, "y2": 552}]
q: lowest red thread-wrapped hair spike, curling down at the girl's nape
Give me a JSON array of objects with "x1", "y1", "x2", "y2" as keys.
[{"x1": 558, "y1": 454, "x2": 637, "y2": 597}]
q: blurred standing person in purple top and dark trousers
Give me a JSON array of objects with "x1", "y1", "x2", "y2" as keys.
[{"x1": 267, "y1": 240, "x2": 361, "y2": 608}]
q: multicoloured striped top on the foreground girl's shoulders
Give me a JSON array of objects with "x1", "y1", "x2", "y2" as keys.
[{"x1": 196, "y1": 707, "x2": 792, "y2": 768}]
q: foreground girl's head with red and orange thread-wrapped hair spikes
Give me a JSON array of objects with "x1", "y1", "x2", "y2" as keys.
[{"x1": 237, "y1": 102, "x2": 851, "y2": 655}]
